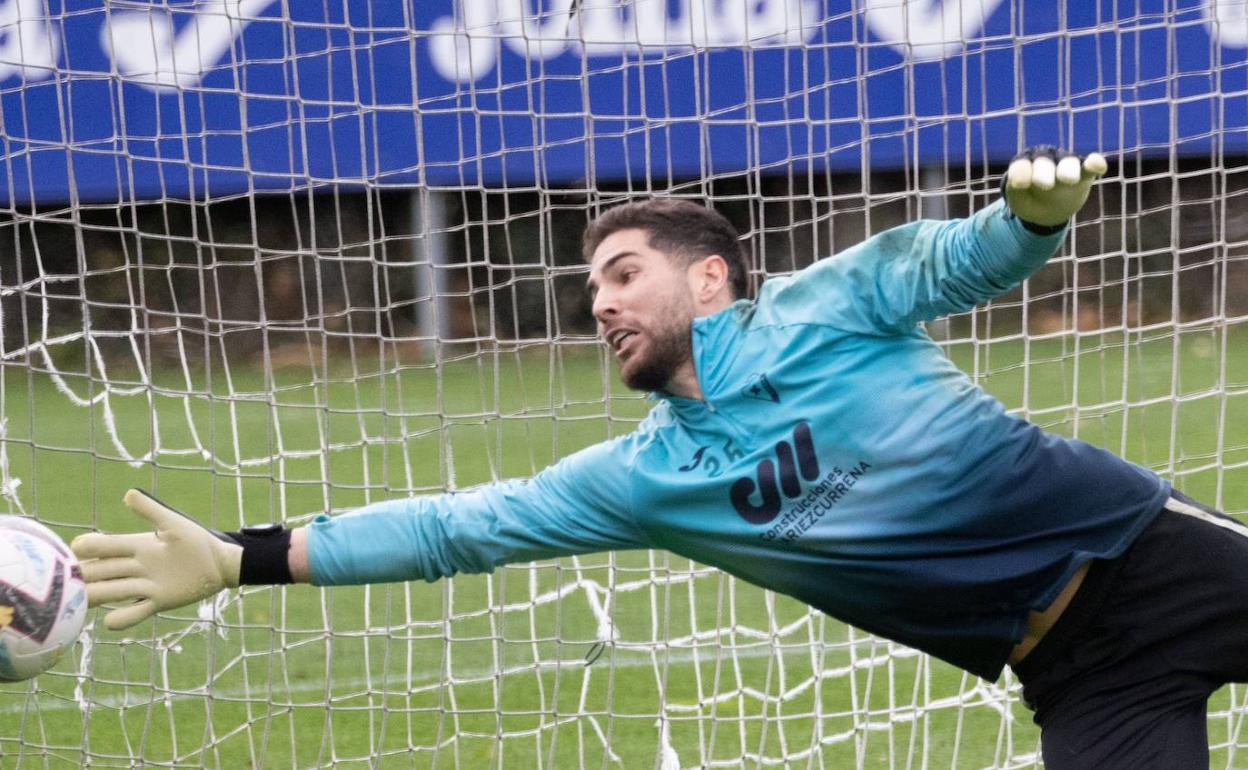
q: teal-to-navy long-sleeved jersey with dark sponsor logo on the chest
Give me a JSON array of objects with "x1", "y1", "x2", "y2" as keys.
[{"x1": 307, "y1": 202, "x2": 1169, "y2": 680}]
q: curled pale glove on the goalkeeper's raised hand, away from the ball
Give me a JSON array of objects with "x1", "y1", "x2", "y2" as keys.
[{"x1": 1002, "y1": 146, "x2": 1108, "y2": 232}]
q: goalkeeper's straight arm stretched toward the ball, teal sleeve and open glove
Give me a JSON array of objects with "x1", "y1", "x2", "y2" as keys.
[{"x1": 71, "y1": 437, "x2": 649, "y2": 630}]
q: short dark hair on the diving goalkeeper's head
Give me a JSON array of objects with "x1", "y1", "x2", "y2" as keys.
[{"x1": 583, "y1": 198, "x2": 749, "y2": 300}]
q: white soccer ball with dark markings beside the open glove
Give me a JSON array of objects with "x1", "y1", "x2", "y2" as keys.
[{"x1": 0, "y1": 515, "x2": 86, "y2": 681}]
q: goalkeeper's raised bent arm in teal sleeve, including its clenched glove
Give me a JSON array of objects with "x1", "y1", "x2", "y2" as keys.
[{"x1": 765, "y1": 149, "x2": 1106, "y2": 333}]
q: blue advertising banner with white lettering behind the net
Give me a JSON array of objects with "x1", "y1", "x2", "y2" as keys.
[{"x1": 0, "y1": 0, "x2": 1248, "y2": 206}]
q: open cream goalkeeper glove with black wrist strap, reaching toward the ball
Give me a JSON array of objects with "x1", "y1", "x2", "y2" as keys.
[{"x1": 70, "y1": 489, "x2": 291, "y2": 630}]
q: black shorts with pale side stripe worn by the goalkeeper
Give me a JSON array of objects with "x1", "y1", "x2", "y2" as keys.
[{"x1": 1013, "y1": 493, "x2": 1248, "y2": 770}]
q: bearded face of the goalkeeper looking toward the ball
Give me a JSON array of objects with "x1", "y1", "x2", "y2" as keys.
[{"x1": 588, "y1": 230, "x2": 694, "y2": 391}]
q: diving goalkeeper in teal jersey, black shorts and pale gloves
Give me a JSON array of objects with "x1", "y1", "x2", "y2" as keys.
[{"x1": 72, "y1": 149, "x2": 1248, "y2": 769}]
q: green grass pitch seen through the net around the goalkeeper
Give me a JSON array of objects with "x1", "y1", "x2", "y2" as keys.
[{"x1": 0, "y1": 327, "x2": 1248, "y2": 770}]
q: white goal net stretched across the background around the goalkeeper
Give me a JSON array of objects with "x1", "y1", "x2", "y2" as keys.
[{"x1": 0, "y1": 0, "x2": 1248, "y2": 770}]
